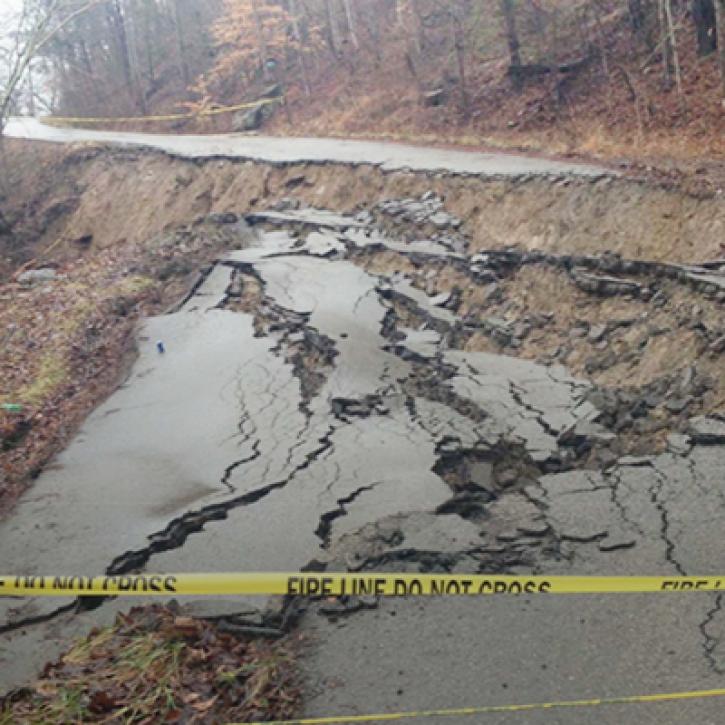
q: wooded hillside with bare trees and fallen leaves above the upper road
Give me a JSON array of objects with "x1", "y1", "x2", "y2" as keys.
[{"x1": 7, "y1": 0, "x2": 725, "y2": 165}]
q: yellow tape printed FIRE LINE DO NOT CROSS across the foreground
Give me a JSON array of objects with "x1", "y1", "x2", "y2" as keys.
[{"x1": 0, "y1": 572, "x2": 725, "y2": 597}]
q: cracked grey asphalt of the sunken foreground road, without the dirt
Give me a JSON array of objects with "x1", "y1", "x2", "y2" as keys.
[{"x1": 0, "y1": 201, "x2": 725, "y2": 724}]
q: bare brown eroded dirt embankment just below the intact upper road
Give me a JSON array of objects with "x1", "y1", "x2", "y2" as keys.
[{"x1": 5, "y1": 142, "x2": 725, "y2": 262}]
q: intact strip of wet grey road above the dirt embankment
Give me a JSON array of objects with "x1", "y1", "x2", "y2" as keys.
[{"x1": 4, "y1": 118, "x2": 614, "y2": 177}]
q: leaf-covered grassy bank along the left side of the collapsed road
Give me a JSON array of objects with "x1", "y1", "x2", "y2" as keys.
[{"x1": 0, "y1": 225, "x2": 235, "y2": 514}]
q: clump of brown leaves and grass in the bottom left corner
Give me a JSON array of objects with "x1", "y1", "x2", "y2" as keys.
[{"x1": 0, "y1": 605, "x2": 299, "y2": 725}]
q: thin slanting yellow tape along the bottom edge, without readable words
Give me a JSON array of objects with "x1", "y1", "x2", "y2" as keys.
[{"x1": 239, "y1": 689, "x2": 725, "y2": 725}]
